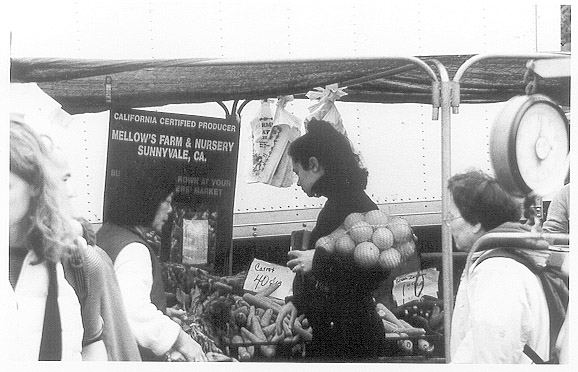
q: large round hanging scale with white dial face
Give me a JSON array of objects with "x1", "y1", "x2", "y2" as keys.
[{"x1": 490, "y1": 94, "x2": 570, "y2": 197}]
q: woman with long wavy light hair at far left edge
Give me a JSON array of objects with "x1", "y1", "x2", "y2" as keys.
[{"x1": 4, "y1": 118, "x2": 83, "y2": 361}]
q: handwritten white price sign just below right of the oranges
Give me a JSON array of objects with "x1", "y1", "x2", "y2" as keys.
[{"x1": 391, "y1": 268, "x2": 440, "y2": 306}]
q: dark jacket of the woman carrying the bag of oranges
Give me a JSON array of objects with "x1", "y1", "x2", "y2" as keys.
[{"x1": 293, "y1": 178, "x2": 388, "y2": 361}]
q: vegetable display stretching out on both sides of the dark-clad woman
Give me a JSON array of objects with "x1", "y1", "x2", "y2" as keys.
[{"x1": 163, "y1": 262, "x2": 445, "y2": 363}]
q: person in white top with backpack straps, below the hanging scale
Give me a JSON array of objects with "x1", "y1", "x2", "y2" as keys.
[{"x1": 444, "y1": 170, "x2": 550, "y2": 364}]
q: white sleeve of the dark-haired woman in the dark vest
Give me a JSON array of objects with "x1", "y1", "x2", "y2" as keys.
[{"x1": 114, "y1": 242, "x2": 181, "y2": 355}]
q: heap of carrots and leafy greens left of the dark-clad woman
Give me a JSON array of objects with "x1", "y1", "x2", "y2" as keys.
[{"x1": 163, "y1": 263, "x2": 313, "y2": 361}]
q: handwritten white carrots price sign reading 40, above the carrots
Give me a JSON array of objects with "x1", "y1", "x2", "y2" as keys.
[{"x1": 243, "y1": 258, "x2": 295, "y2": 300}]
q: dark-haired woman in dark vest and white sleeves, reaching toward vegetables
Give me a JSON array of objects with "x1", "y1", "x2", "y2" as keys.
[{"x1": 96, "y1": 166, "x2": 207, "y2": 362}]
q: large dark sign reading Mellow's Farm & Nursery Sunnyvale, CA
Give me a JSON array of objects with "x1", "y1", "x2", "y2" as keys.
[{"x1": 104, "y1": 108, "x2": 239, "y2": 271}]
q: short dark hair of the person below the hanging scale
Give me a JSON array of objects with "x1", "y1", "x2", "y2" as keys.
[{"x1": 448, "y1": 170, "x2": 522, "y2": 231}]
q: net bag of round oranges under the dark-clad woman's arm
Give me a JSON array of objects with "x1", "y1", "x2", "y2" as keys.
[{"x1": 315, "y1": 210, "x2": 417, "y2": 270}]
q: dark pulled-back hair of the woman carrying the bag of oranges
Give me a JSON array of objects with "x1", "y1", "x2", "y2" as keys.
[{"x1": 289, "y1": 119, "x2": 368, "y2": 190}]
